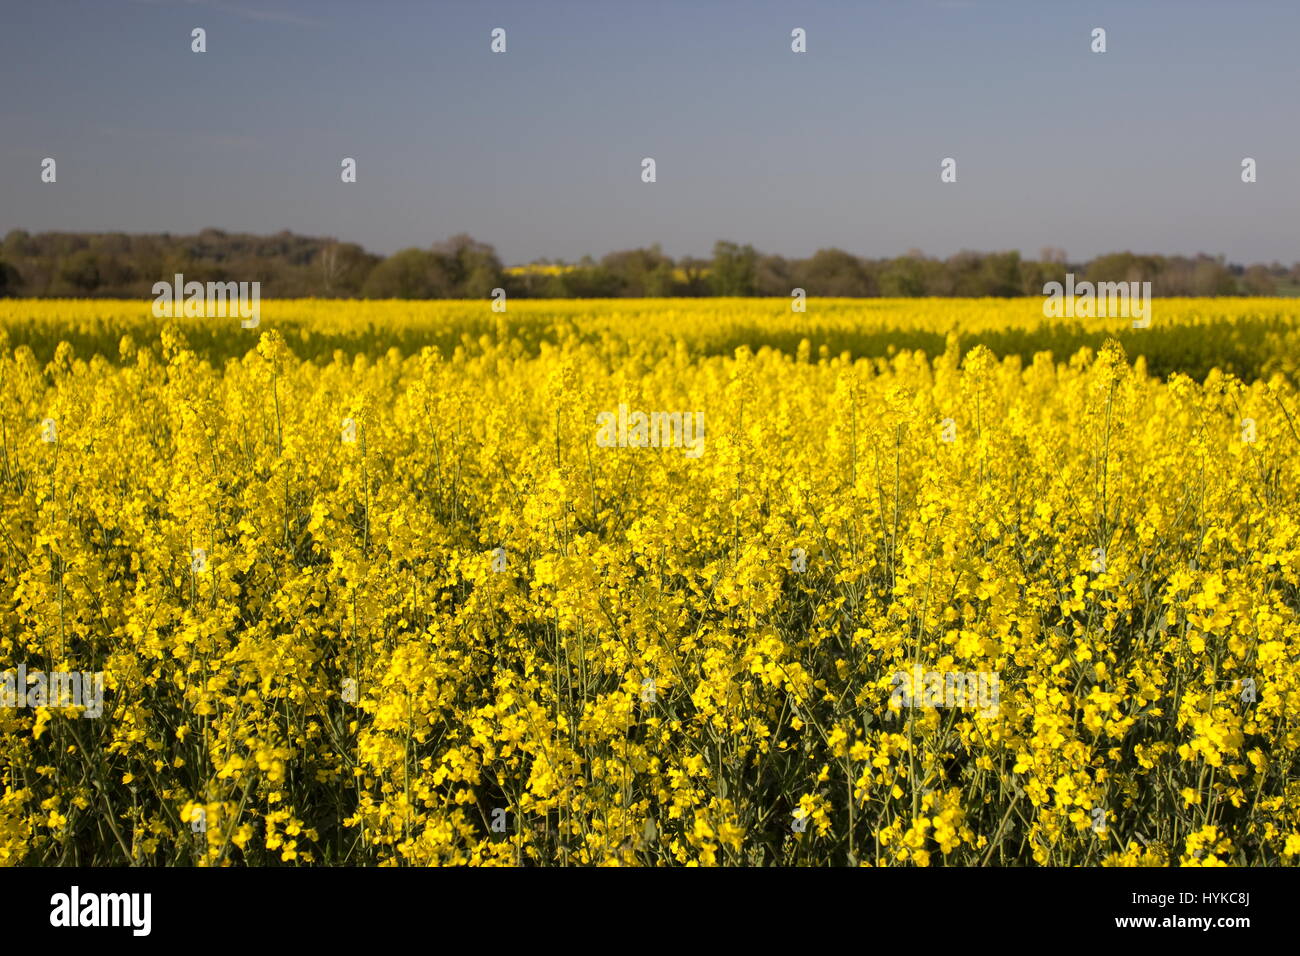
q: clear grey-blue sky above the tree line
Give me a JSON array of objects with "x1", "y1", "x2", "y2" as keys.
[{"x1": 0, "y1": 0, "x2": 1300, "y2": 263}]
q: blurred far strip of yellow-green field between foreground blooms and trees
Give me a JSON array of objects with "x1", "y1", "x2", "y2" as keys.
[{"x1": 0, "y1": 298, "x2": 1300, "y2": 380}]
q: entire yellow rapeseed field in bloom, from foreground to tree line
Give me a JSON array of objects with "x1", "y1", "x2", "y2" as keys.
[{"x1": 0, "y1": 300, "x2": 1300, "y2": 866}]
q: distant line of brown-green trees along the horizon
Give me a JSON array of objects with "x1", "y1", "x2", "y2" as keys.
[{"x1": 0, "y1": 229, "x2": 1300, "y2": 299}]
